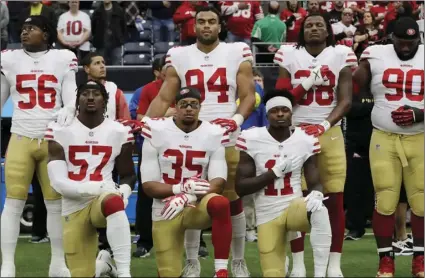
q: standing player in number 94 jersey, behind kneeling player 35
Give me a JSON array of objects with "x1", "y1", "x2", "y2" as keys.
[{"x1": 146, "y1": 7, "x2": 255, "y2": 277}]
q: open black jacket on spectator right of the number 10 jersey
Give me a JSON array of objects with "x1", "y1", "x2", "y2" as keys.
[{"x1": 91, "y1": 2, "x2": 127, "y2": 48}]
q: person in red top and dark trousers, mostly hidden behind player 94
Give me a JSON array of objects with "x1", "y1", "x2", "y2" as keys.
[{"x1": 133, "y1": 55, "x2": 165, "y2": 258}]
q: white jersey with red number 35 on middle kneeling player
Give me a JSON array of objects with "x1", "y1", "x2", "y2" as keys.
[{"x1": 141, "y1": 118, "x2": 228, "y2": 221}]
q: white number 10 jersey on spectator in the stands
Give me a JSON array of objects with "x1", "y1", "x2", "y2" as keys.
[{"x1": 57, "y1": 11, "x2": 91, "y2": 51}]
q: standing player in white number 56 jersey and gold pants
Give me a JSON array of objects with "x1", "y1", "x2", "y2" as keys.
[{"x1": 0, "y1": 16, "x2": 78, "y2": 277}]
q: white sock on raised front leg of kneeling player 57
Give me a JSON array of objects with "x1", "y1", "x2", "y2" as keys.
[{"x1": 106, "y1": 210, "x2": 131, "y2": 277}]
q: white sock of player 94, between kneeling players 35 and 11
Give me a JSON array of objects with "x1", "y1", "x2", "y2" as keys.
[{"x1": 232, "y1": 211, "x2": 246, "y2": 260}]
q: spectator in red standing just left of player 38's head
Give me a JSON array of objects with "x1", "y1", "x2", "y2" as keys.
[{"x1": 280, "y1": 0, "x2": 307, "y2": 42}]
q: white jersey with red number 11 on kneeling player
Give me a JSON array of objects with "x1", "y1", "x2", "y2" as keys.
[{"x1": 236, "y1": 127, "x2": 320, "y2": 226}]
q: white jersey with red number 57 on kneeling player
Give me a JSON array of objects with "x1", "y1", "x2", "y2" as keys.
[{"x1": 44, "y1": 118, "x2": 134, "y2": 215}]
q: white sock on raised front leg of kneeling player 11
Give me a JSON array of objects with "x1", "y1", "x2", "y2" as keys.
[{"x1": 310, "y1": 207, "x2": 332, "y2": 277}]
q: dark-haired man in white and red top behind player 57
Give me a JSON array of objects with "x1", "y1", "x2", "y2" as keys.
[{"x1": 81, "y1": 52, "x2": 131, "y2": 120}]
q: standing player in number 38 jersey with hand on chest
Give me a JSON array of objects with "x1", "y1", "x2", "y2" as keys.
[{"x1": 274, "y1": 13, "x2": 357, "y2": 277}]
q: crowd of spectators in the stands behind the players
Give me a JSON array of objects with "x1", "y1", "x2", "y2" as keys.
[{"x1": 0, "y1": 0, "x2": 424, "y2": 65}]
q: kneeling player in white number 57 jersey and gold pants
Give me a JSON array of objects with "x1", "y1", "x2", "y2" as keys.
[{"x1": 45, "y1": 81, "x2": 136, "y2": 277}]
